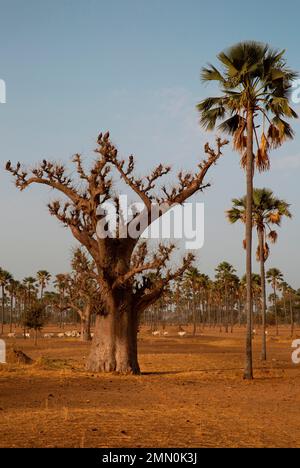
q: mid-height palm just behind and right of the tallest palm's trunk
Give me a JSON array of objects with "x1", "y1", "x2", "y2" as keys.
[{"x1": 227, "y1": 188, "x2": 292, "y2": 361}]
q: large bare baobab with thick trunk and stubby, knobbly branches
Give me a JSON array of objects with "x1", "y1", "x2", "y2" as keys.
[{"x1": 6, "y1": 132, "x2": 228, "y2": 374}]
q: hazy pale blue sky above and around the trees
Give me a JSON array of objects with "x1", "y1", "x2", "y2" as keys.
[{"x1": 0, "y1": 0, "x2": 300, "y2": 287}]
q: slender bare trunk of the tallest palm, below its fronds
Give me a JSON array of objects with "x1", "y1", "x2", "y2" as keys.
[{"x1": 244, "y1": 108, "x2": 253, "y2": 380}]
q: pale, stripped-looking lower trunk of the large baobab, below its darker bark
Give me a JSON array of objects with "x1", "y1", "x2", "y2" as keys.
[{"x1": 86, "y1": 307, "x2": 140, "y2": 374}]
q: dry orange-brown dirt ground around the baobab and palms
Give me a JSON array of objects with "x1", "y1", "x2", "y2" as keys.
[{"x1": 0, "y1": 328, "x2": 300, "y2": 448}]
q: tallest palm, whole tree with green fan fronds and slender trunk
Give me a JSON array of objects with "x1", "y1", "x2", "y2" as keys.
[{"x1": 198, "y1": 38, "x2": 297, "y2": 379}]
